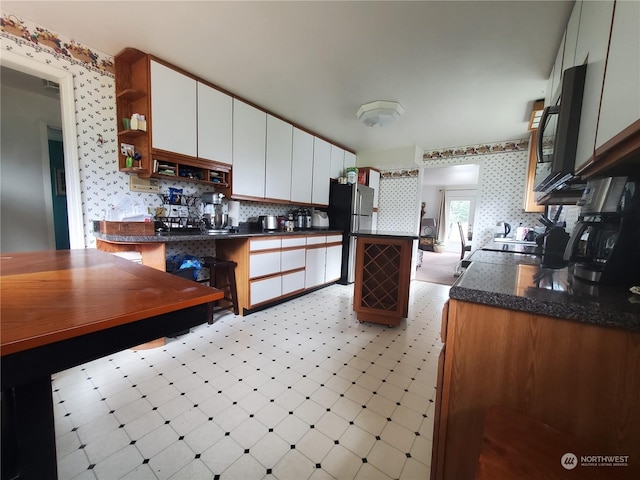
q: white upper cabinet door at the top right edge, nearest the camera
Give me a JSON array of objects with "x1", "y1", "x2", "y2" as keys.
[{"x1": 596, "y1": 1, "x2": 640, "y2": 149}]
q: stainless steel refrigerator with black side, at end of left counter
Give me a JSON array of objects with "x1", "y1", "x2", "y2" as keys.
[{"x1": 328, "y1": 182, "x2": 373, "y2": 285}]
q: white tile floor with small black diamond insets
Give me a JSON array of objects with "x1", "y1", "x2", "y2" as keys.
[{"x1": 53, "y1": 282, "x2": 449, "y2": 480}]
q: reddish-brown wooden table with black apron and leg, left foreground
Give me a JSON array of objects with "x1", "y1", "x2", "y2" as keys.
[{"x1": 0, "y1": 249, "x2": 223, "y2": 480}]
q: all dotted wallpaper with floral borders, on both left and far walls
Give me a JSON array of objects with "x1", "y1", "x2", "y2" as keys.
[{"x1": 0, "y1": 11, "x2": 538, "y2": 255}]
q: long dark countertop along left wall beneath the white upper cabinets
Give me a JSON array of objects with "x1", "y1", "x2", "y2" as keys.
[{"x1": 94, "y1": 229, "x2": 342, "y2": 243}]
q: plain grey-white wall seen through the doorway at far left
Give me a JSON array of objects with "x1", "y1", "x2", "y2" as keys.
[{"x1": 0, "y1": 86, "x2": 61, "y2": 252}]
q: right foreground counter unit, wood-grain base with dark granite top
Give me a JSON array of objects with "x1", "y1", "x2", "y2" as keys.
[{"x1": 431, "y1": 249, "x2": 640, "y2": 479}]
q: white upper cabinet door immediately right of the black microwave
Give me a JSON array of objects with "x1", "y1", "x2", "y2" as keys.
[{"x1": 575, "y1": 2, "x2": 616, "y2": 170}]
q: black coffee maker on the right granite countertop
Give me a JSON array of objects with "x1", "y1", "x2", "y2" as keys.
[{"x1": 564, "y1": 177, "x2": 640, "y2": 286}]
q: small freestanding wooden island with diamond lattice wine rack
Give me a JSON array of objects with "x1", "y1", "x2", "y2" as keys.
[{"x1": 352, "y1": 230, "x2": 418, "y2": 326}]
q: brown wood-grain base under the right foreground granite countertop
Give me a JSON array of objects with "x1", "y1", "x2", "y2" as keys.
[{"x1": 431, "y1": 300, "x2": 640, "y2": 479}]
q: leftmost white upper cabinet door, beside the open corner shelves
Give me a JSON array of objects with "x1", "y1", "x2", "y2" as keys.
[{"x1": 151, "y1": 60, "x2": 198, "y2": 157}]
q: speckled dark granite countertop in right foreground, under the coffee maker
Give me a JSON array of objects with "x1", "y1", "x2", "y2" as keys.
[{"x1": 449, "y1": 246, "x2": 640, "y2": 332}]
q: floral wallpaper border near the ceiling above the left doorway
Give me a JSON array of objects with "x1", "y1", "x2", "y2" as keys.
[{"x1": 0, "y1": 13, "x2": 115, "y2": 75}]
